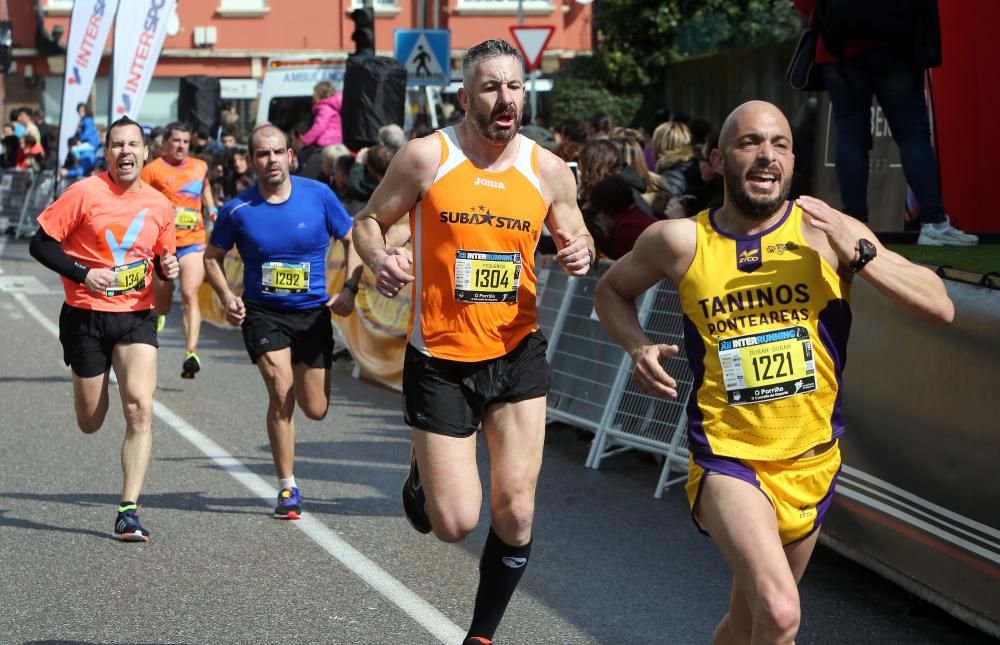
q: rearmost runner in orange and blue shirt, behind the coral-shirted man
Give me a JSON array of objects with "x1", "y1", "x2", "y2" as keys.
[{"x1": 142, "y1": 123, "x2": 218, "y2": 378}]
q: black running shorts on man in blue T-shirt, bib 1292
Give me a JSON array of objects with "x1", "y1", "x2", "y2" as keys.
[{"x1": 243, "y1": 301, "x2": 333, "y2": 369}]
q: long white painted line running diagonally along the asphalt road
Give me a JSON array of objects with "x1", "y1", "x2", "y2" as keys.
[{"x1": 11, "y1": 292, "x2": 465, "y2": 645}]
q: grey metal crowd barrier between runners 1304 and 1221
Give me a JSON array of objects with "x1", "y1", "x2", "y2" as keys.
[{"x1": 538, "y1": 256, "x2": 692, "y2": 498}]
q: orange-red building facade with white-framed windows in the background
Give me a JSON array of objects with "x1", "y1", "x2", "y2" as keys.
[{"x1": 0, "y1": 0, "x2": 593, "y2": 131}]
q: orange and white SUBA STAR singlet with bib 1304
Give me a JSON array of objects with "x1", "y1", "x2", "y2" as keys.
[{"x1": 409, "y1": 128, "x2": 549, "y2": 362}]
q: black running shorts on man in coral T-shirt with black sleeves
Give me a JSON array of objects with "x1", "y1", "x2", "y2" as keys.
[{"x1": 59, "y1": 303, "x2": 160, "y2": 378}]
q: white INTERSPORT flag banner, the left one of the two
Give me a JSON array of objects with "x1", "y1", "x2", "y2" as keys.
[{"x1": 59, "y1": 0, "x2": 118, "y2": 166}]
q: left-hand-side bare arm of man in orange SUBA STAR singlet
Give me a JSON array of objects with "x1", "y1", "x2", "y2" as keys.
[{"x1": 353, "y1": 136, "x2": 441, "y2": 298}]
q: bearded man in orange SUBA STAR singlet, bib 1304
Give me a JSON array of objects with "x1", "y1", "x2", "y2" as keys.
[{"x1": 354, "y1": 40, "x2": 594, "y2": 645}]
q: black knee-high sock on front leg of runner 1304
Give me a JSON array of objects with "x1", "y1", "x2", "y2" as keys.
[{"x1": 466, "y1": 526, "x2": 531, "y2": 639}]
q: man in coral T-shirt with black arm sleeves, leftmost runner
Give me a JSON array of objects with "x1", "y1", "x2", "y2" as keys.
[{"x1": 30, "y1": 117, "x2": 179, "y2": 542}]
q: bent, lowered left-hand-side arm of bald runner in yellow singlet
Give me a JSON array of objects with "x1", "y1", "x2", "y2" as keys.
[{"x1": 594, "y1": 219, "x2": 696, "y2": 399}]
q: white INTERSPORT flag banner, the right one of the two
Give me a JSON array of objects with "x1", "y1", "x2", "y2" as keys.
[{"x1": 111, "y1": 0, "x2": 177, "y2": 121}]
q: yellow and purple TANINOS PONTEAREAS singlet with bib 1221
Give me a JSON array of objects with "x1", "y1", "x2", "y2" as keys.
[{"x1": 679, "y1": 203, "x2": 851, "y2": 460}]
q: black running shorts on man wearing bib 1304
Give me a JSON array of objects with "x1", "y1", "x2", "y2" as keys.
[{"x1": 403, "y1": 331, "x2": 552, "y2": 437}]
